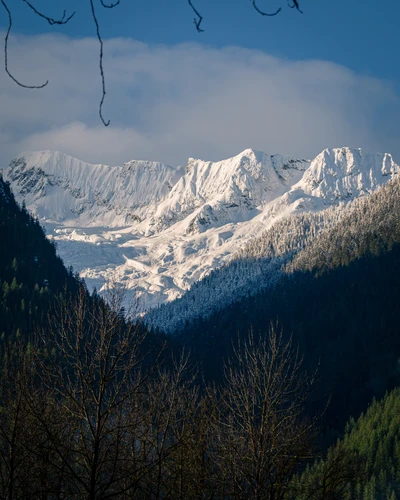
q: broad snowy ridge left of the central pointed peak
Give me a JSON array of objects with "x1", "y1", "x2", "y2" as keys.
[{"x1": 4, "y1": 151, "x2": 180, "y2": 226}]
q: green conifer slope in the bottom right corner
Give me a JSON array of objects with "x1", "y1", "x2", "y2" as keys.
[{"x1": 295, "y1": 388, "x2": 400, "y2": 500}]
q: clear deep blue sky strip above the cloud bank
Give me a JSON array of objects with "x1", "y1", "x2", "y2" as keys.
[{"x1": 7, "y1": 0, "x2": 400, "y2": 80}]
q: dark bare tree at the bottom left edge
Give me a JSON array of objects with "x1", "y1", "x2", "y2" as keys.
[{"x1": 0, "y1": 343, "x2": 63, "y2": 500}]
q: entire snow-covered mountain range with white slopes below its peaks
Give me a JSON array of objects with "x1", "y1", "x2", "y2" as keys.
[{"x1": 3, "y1": 148, "x2": 400, "y2": 307}]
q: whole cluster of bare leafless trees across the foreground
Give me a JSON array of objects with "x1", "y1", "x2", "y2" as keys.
[{"x1": 0, "y1": 287, "x2": 334, "y2": 500}]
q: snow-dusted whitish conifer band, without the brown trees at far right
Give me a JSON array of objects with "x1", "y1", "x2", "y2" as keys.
[{"x1": 145, "y1": 204, "x2": 351, "y2": 334}]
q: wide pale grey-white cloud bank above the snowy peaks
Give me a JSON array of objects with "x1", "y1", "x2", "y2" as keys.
[{"x1": 0, "y1": 35, "x2": 400, "y2": 164}]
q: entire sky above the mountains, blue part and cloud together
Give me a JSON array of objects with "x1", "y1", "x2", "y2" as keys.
[{"x1": 0, "y1": 0, "x2": 400, "y2": 163}]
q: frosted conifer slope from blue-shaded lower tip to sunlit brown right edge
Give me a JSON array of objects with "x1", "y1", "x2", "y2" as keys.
[{"x1": 147, "y1": 173, "x2": 400, "y2": 333}]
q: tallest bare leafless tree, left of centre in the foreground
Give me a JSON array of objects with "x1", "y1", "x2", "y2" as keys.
[{"x1": 31, "y1": 288, "x2": 160, "y2": 499}]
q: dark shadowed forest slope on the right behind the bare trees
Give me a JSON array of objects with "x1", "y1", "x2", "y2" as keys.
[{"x1": 180, "y1": 246, "x2": 400, "y2": 438}]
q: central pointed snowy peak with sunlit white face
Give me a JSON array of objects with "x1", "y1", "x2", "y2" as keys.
[{"x1": 150, "y1": 149, "x2": 309, "y2": 234}]
